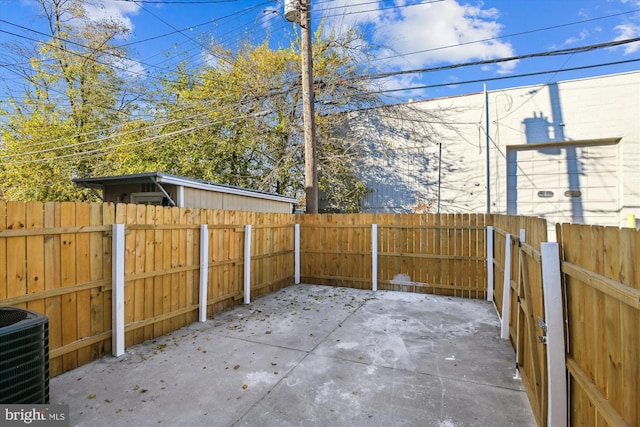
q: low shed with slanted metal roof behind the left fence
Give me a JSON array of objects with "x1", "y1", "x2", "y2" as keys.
[{"x1": 73, "y1": 172, "x2": 297, "y2": 213}]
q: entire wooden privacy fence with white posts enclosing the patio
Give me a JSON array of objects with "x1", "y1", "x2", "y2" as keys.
[{"x1": 0, "y1": 202, "x2": 640, "y2": 426}]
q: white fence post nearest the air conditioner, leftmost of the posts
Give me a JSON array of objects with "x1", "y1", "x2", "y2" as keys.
[{"x1": 111, "y1": 224, "x2": 124, "y2": 357}]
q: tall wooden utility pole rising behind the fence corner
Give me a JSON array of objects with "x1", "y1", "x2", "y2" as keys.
[{"x1": 285, "y1": 0, "x2": 318, "y2": 213}]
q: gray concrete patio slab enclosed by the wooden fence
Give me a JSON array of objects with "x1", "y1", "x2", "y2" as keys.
[{"x1": 50, "y1": 285, "x2": 535, "y2": 427}]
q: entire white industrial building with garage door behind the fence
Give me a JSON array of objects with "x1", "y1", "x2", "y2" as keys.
[{"x1": 347, "y1": 72, "x2": 640, "y2": 231}]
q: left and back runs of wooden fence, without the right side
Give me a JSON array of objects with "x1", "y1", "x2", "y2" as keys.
[{"x1": 0, "y1": 207, "x2": 487, "y2": 375}]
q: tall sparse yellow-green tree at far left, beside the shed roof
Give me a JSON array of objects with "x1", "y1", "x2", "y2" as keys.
[{"x1": 0, "y1": 0, "x2": 140, "y2": 200}]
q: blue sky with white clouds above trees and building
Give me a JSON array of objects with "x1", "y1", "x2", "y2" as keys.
[{"x1": 0, "y1": 0, "x2": 640, "y2": 102}]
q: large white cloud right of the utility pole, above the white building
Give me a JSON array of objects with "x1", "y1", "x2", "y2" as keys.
[{"x1": 325, "y1": 0, "x2": 516, "y2": 73}]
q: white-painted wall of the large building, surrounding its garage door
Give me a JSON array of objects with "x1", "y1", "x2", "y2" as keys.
[{"x1": 350, "y1": 72, "x2": 640, "y2": 229}]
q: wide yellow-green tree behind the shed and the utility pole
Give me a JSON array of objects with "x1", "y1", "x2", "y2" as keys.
[{"x1": 111, "y1": 24, "x2": 379, "y2": 212}]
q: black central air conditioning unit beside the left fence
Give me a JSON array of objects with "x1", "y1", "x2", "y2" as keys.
[{"x1": 0, "y1": 307, "x2": 49, "y2": 404}]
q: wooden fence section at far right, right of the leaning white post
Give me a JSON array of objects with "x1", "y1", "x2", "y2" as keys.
[{"x1": 557, "y1": 224, "x2": 640, "y2": 426}]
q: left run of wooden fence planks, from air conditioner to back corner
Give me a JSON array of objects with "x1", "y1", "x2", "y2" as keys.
[{"x1": 0, "y1": 202, "x2": 293, "y2": 376}]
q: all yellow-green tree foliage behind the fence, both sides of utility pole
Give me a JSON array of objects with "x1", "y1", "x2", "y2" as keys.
[{"x1": 0, "y1": 0, "x2": 379, "y2": 212}]
